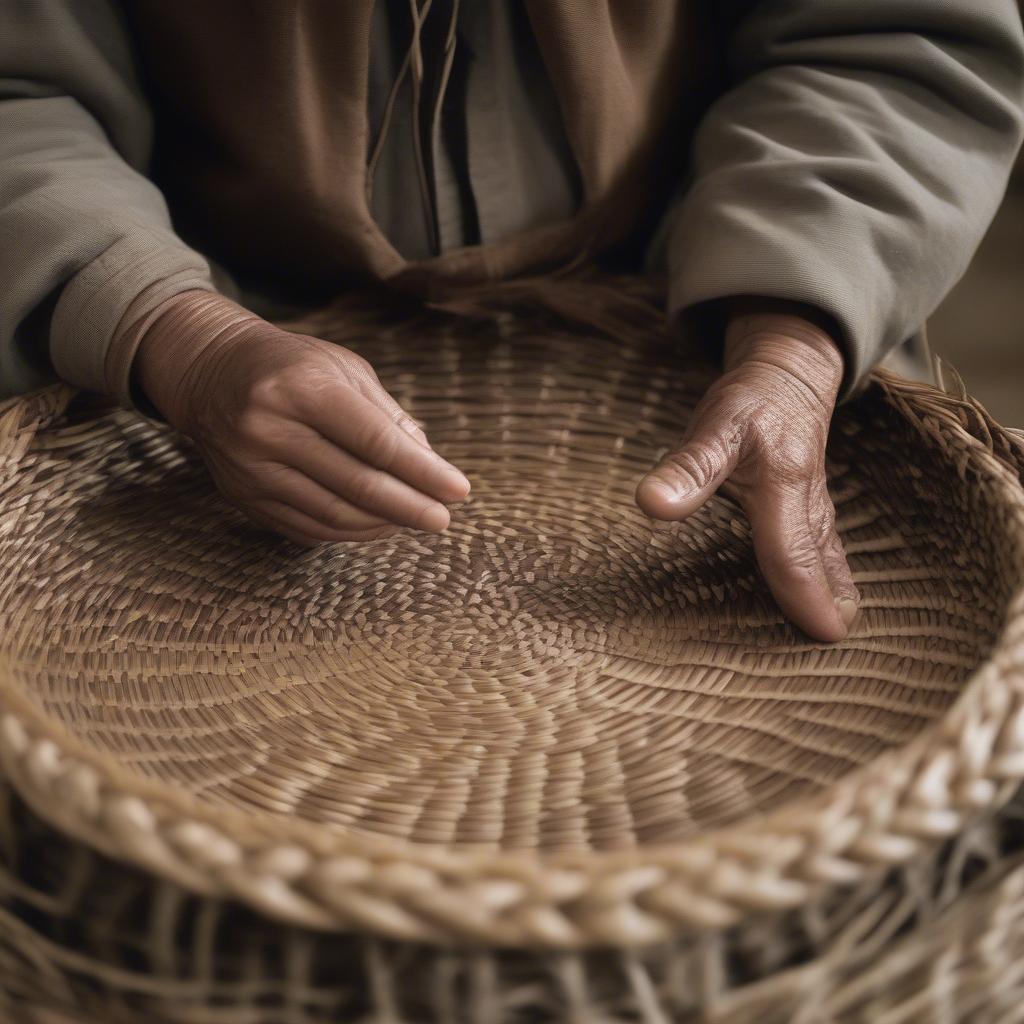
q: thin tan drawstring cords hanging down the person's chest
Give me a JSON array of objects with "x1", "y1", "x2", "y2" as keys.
[{"x1": 366, "y1": 0, "x2": 460, "y2": 252}]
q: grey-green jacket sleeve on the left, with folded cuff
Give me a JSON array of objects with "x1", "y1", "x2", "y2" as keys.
[{"x1": 0, "y1": 0, "x2": 213, "y2": 395}]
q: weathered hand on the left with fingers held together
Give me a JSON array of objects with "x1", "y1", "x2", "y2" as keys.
[{"x1": 133, "y1": 292, "x2": 469, "y2": 544}]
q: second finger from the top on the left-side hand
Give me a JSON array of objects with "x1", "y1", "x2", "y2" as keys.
[{"x1": 270, "y1": 434, "x2": 452, "y2": 532}]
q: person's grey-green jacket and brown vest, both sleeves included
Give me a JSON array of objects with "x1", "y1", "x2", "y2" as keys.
[{"x1": 0, "y1": 0, "x2": 1024, "y2": 395}]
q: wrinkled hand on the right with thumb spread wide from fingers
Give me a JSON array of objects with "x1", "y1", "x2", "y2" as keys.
[{"x1": 637, "y1": 312, "x2": 859, "y2": 641}]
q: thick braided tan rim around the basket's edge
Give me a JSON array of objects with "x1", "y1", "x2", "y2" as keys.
[{"x1": 0, "y1": 371, "x2": 1024, "y2": 949}]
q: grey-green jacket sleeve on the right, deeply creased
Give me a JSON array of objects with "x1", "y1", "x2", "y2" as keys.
[{"x1": 664, "y1": 0, "x2": 1024, "y2": 390}]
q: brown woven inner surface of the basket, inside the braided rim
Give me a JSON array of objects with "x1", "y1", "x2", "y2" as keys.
[{"x1": 0, "y1": 299, "x2": 1006, "y2": 850}]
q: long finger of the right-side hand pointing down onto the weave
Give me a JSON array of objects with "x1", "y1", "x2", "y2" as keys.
[{"x1": 741, "y1": 470, "x2": 856, "y2": 642}]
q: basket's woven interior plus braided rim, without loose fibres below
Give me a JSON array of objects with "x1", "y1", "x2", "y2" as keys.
[{"x1": 0, "y1": 278, "x2": 1024, "y2": 945}]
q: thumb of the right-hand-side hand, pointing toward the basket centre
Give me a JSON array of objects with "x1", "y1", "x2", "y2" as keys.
[{"x1": 636, "y1": 424, "x2": 741, "y2": 520}]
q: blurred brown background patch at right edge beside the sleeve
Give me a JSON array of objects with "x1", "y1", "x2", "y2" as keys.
[{"x1": 928, "y1": 160, "x2": 1024, "y2": 427}]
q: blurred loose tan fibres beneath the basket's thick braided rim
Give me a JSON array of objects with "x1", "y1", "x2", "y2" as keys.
[{"x1": 6, "y1": 778, "x2": 1024, "y2": 1024}]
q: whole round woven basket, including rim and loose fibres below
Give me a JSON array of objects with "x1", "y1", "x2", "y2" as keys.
[{"x1": 0, "y1": 282, "x2": 1024, "y2": 1024}]
